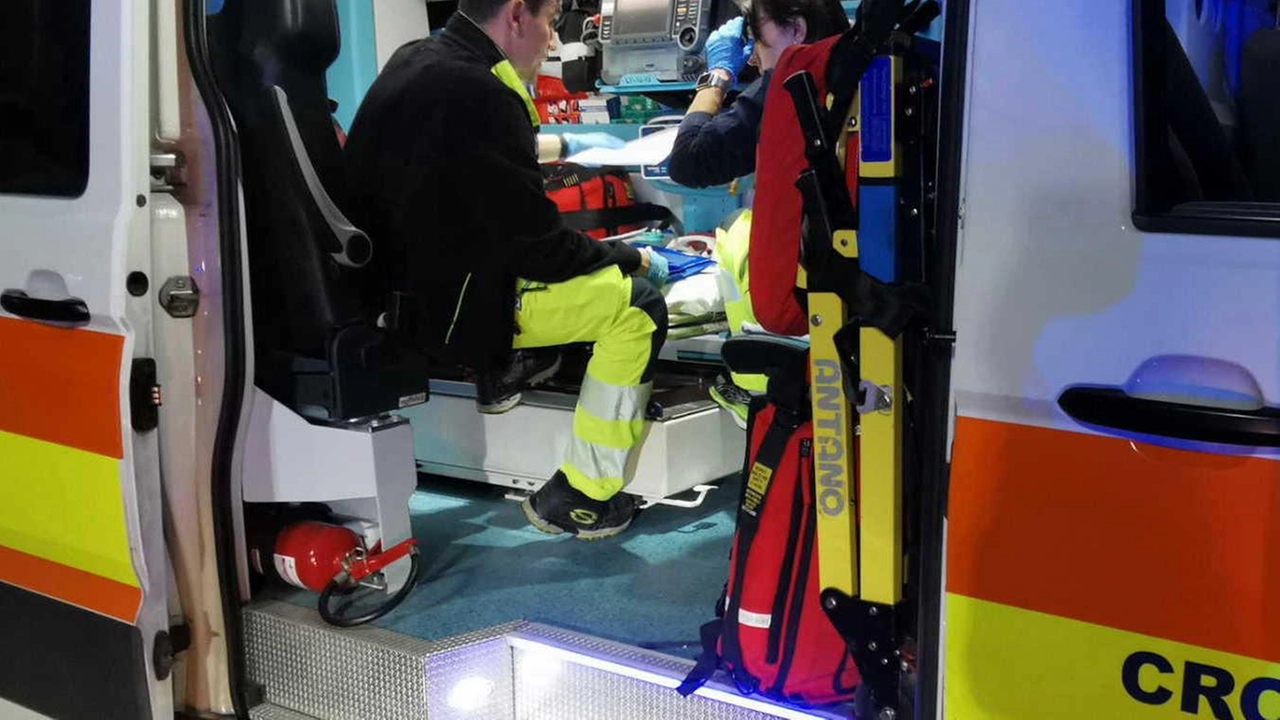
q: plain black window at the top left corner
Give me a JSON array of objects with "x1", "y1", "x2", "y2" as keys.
[{"x1": 0, "y1": 0, "x2": 91, "y2": 197}]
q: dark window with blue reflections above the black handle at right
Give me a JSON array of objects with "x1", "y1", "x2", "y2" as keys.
[{"x1": 1133, "y1": 0, "x2": 1280, "y2": 237}]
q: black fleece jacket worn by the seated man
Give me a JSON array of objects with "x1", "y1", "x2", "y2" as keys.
[{"x1": 344, "y1": 14, "x2": 640, "y2": 368}]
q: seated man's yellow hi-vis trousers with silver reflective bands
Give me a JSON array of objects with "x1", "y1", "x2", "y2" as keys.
[{"x1": 513, "y1": 265, "x2": 667, "y2": 500}]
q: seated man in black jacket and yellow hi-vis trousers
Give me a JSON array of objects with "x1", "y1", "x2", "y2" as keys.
[{"x1": 344, "y1": 0, "x2": 667, "y2": 538}]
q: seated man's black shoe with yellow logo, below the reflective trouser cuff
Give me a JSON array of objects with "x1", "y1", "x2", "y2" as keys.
[{"x1": 521, "y1": 470, "x2": 636, "y2": 539}]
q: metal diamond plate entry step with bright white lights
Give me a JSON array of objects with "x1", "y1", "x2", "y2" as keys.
[{"x1": 244, "y1": 602, "x2": 851, "y2": 720}]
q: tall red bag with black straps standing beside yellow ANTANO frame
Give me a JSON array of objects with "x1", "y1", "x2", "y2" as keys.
[{"x1": 680, "y1": 404, "x2": 861, "y2": 706}]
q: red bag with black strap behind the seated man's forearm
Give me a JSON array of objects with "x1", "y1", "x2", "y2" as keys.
[{"x1": 543, "y1": 163, "x2": 677, "y2": 240}]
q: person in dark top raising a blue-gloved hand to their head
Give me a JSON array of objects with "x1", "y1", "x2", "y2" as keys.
[{"x1": 668, "y1": 0, "x2": 849, "y2": 187}]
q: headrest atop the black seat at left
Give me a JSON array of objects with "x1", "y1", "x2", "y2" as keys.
[{"x1": 246, "y1": 0, "x2": 342, "y2": 73}]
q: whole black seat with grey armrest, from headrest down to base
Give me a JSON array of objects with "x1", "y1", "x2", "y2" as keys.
[{"x1": 210, "y1": 0, "x2": 426, "y2": 419}]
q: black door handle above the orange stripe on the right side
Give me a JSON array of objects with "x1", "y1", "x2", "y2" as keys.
[{"x1": 1057, "y1": 387, "x2": 1280, "y2": 447}]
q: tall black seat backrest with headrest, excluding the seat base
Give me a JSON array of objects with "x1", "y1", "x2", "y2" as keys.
[{"x1": 211, "y1": 0, "x2": 361, "y2": 348}]
